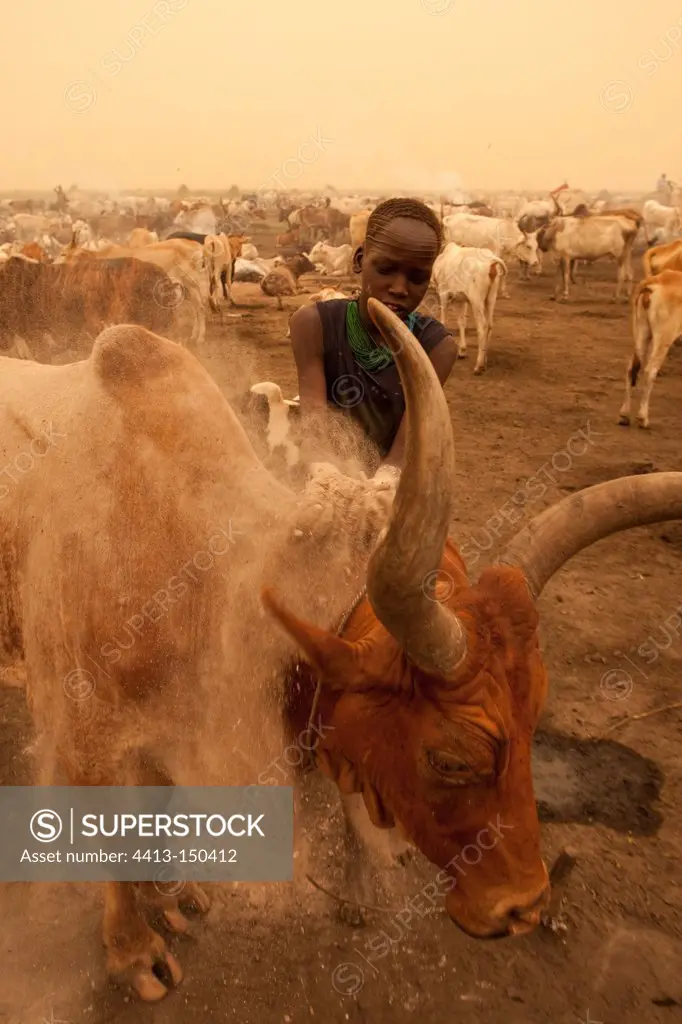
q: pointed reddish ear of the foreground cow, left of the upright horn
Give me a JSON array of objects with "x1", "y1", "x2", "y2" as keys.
[{"x1": 261, "y1": 588, "x2": 368, "y2": 690}]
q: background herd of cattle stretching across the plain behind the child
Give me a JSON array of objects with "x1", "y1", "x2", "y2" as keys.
[{"x1": 0, "y1": 185, "x2": 682, "y2": 426}]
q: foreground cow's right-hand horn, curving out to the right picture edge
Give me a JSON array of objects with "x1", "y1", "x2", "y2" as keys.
[{"x1": 498, "y1": 473, "x2": 682, "y2": 598}]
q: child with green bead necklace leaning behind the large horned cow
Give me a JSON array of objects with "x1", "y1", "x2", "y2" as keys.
[{"x1": 290, "y1": 199, "x2": 457, "y2": 482}]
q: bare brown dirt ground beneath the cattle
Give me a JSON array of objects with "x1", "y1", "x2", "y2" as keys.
[{"x1": 0, "y1": 232, "x2": 682, "y2": 1024}]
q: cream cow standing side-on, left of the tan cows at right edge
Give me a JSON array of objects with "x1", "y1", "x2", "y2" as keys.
[{"x1": 538, "y1": 213, "x2": 637, "y2": 301}]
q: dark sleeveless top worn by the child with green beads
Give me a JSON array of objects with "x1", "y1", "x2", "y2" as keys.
[{"x1": 316, "y1": 299, "x2": 450, "y2": 458}]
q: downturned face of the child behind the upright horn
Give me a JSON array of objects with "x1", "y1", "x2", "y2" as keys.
[{"x1": 359, "y1": 217, "x2": 438, "y2": 323}]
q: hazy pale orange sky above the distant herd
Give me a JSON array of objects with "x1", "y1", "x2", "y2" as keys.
[{"x1": 0, "y1": 0, "x2": 682, "y2": 189}]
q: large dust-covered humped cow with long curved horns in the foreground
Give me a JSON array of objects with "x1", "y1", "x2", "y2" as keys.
[{"x1": 0, "y1": 303, "x2": 682, "y2": 1001}]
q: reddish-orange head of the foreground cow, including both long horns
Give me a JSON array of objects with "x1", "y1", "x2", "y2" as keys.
[{"x1": 263, "y1": 299, "x2": 682, "y2": 938}]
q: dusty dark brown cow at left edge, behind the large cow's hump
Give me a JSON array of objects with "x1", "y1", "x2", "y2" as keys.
[{"x1": 0, "y1": 257, "x2": 177, "y2": 362}]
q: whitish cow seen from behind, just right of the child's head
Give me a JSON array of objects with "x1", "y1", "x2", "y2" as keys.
[{"x1": 431, "y1": 242, "x2": 507, "y2": 374}]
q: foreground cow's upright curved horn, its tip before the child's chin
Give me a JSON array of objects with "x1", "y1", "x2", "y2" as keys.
[{"x1": 360, "y1": 299, "x2": 466, "y2": 677}]
